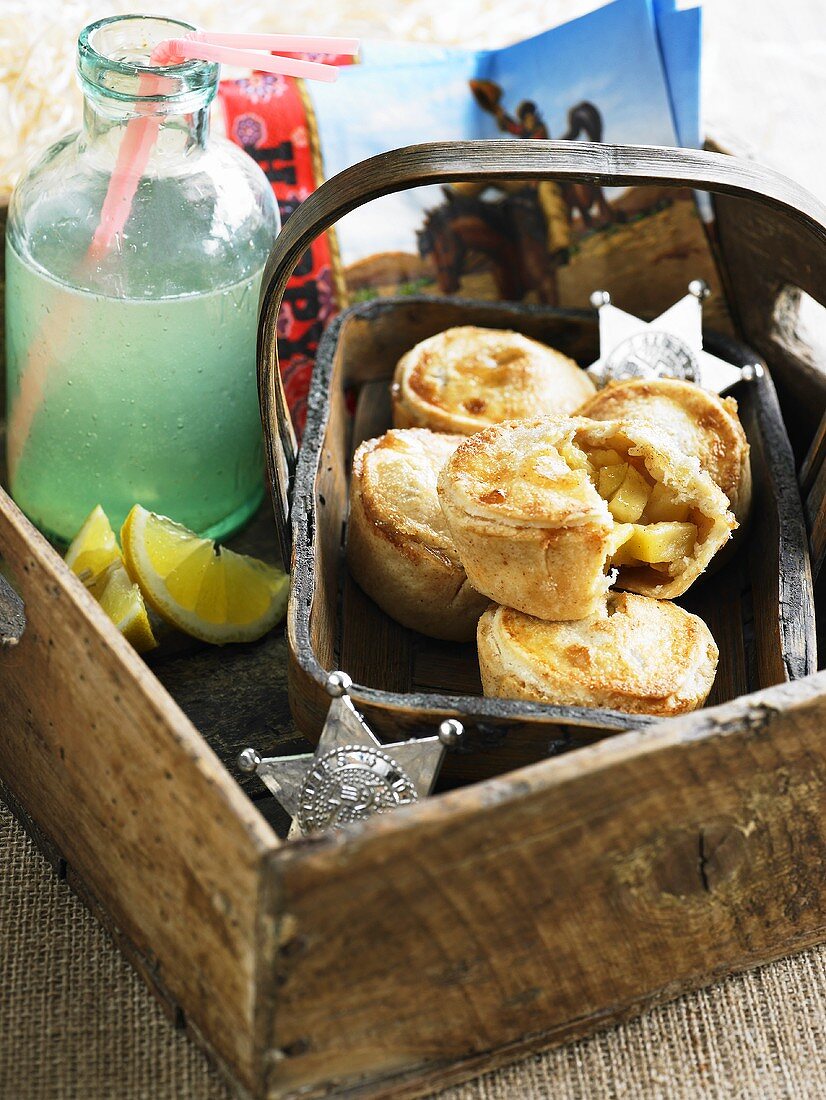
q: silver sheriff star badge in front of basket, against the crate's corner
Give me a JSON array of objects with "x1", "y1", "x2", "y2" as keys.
[{"x1": 238, "y1": 672, "x2": 463, "y2": 836}]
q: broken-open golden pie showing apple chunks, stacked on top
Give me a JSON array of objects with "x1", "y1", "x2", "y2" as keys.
[{"x1": 439, "y1": 417, "x2": 736, "y2": 619}]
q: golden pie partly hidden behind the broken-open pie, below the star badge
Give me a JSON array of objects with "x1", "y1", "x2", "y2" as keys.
[{"x1": 577, "y1": 378, "x2": 751, "y2": 525}]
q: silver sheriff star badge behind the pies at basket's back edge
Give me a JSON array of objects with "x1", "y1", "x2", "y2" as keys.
[{"x1": 588, "y1": 278, "x2": 763, "y2": 394}]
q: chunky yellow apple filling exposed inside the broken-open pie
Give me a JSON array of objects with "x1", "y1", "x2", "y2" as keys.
[{"x1": 565, "y1": 447, "x2": 698, "y2": 576}]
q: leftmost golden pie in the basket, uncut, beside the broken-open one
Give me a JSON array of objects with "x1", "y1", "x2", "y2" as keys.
[{"x1": 348, "y1": 428, "x2": 487, "y2": 641}]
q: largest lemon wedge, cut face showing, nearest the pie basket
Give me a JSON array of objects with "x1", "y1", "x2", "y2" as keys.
[{"x1": 121, "y1": 504, "x2": 289, "y2": 646}]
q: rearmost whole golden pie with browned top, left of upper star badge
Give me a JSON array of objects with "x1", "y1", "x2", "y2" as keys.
[{"x1": 393, "y1": 325, "x2": 594, "y2": 436}]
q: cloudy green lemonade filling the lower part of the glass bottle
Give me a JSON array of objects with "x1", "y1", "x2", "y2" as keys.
[{"x1": 5, "y1": 244, "x2": 263, "y2": 541}]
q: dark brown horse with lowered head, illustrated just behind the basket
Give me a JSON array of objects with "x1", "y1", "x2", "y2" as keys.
[{"x1": 416, "y1": 187, "x2": 559, "y2": 306}]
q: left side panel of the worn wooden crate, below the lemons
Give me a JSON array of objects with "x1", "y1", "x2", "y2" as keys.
[{"x1": 0, "y1": 491, "x2": 278, "y2": 1084}]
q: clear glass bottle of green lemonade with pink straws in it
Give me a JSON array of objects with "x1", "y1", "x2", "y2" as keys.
[{"x1": 5, "y1": 15, "x2": 278, "y2": 541}]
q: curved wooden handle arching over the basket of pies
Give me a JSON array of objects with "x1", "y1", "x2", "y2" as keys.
[{"x1": 257, "y1": 139, "x2": 826, "y2": 565}]
